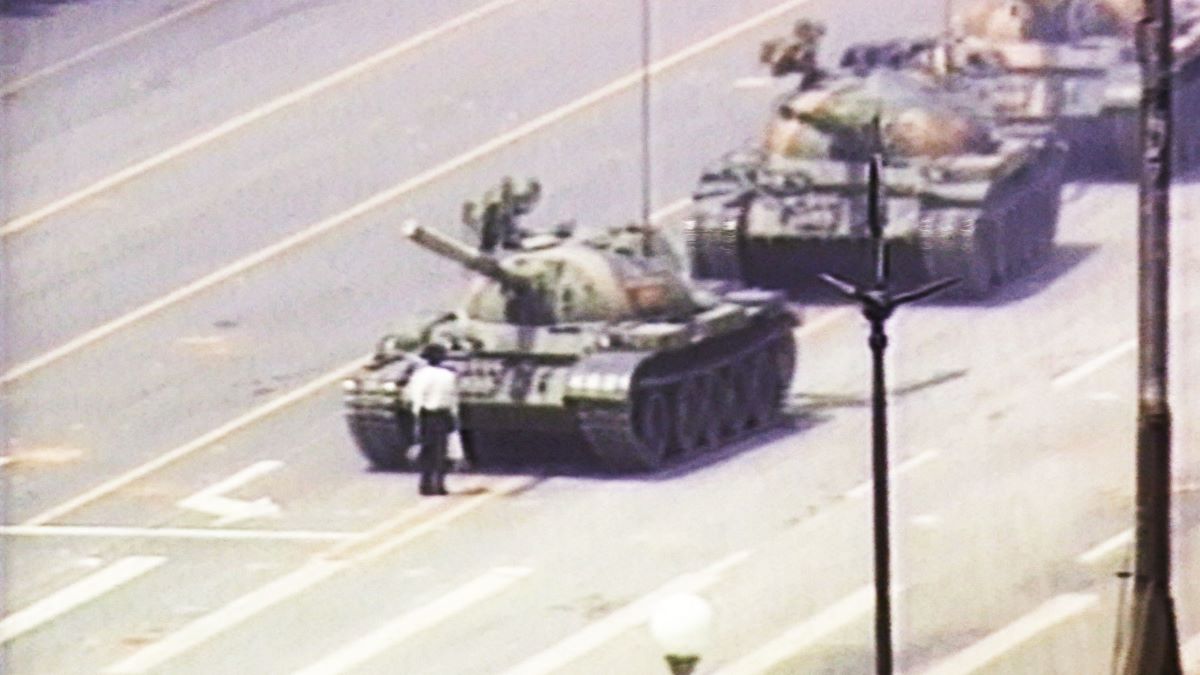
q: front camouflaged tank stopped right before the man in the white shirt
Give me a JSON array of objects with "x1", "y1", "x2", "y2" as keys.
[{"x1": 344, "y1": 212, "x2": 797, "y2": 471}]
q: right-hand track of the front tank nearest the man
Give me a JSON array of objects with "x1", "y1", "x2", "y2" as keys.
[{"x1": 576, "y1": 317, "x2": 796, "y2": 472}]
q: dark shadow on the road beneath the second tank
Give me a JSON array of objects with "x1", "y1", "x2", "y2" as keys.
[{"x1": 787, "y1": 244, "x2": 1099, "y2": 307}]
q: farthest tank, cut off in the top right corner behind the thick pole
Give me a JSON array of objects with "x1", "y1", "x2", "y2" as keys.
[{"x1": 841, "y1": 0, "x2": 1200, "y2": 175}]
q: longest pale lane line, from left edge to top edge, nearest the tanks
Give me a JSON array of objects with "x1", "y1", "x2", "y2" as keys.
[{"x1": 0, "y1": 0, "x2": 825, "y2": 384}]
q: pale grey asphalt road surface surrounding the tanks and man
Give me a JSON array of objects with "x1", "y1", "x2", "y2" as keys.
[{"x1": 0, "y1": 0, "x2": 1200, "y2": 674}]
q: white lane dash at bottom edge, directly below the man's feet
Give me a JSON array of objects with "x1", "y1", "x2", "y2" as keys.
[{"x1": 294, "y1": 567, "x2": 532, "y2": 675}]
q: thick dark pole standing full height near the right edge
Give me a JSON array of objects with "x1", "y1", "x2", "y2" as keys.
[{"x1": 1122, "y1": 0, "x2": 1182, "y2": 675}]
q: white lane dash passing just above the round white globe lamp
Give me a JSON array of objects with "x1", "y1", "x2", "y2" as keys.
[{"x1": 504, "y1": 551, "x2": 750, "y2": 675}]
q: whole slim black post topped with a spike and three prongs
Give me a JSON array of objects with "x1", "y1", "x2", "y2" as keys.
[{"x1": 821, "y1": 153, "x2": 959, "y2": 675}]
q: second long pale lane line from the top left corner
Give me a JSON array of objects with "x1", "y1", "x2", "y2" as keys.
[{"x1": 0, "y1": 0, "x2": 521, "y2": 237}]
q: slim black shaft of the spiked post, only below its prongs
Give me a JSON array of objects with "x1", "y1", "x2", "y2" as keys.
[{"x1": 870, "y1": 317, "x2": 892, "y2": 675}]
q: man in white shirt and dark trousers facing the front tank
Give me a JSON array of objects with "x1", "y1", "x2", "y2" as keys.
[{"x1": 408, "y1": 342, "x2": 458, "y2": 495}]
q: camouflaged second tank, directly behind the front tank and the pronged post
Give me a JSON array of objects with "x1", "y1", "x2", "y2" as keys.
[{"x1": 685, "y1": 71, "x2": 1066, "y2": 298}]
